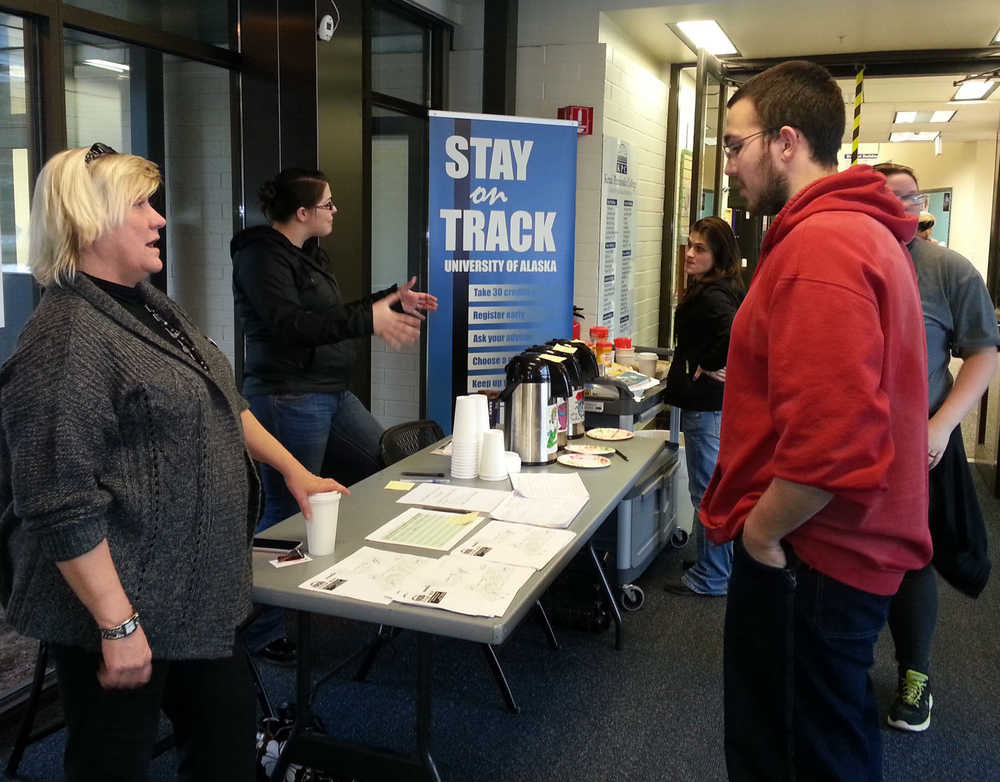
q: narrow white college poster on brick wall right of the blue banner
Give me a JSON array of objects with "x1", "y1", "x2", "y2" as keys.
[{"x1": 596, "y1": 136, "x2": 637, "y2": 338}]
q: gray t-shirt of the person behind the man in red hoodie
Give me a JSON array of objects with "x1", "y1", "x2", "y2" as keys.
[{"x1": 908, "y1": 238, "x2": 1000, "y2": 415}]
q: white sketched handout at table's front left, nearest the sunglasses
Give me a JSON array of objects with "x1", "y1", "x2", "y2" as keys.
[{"x1": 299, "y1": 546, "x2": 434, "y2": 605}]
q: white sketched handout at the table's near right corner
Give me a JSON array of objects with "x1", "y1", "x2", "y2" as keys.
[{"x1": 393, "y1": 554, "x2": 535, "y2": 616}]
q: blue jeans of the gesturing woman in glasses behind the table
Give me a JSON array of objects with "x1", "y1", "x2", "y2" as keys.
[{"x1": 246, "y1": 391, "x2": 382, "y2": 651}]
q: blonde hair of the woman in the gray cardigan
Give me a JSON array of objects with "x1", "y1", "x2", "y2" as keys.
[{"x1": 28, "y1": 147, "x2": 163, "y2": 286}]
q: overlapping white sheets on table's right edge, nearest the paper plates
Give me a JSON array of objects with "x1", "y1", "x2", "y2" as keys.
[{"x1": 490, "y1": 473, "x2": 590, "y2": 529}]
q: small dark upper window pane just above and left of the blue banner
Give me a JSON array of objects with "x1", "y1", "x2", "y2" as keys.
[{"x1": 372, "y1": 8, "x2": 428, "y2": 106}]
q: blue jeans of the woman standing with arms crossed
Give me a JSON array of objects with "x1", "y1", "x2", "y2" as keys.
[{"x1": 681, "y1": 410, "x2": 733, "y2": 595}]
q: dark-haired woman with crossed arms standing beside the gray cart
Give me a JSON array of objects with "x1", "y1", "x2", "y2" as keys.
[{"x1": 664, "y1": 217, "x2": 745, "y2": 596}]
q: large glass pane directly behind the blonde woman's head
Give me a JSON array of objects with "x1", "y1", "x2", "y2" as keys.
[{"x1": 65, "y1": 29, "x2": 234, "y2": 361}]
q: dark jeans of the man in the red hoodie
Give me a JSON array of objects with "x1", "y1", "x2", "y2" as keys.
[{"x1": 724, "y1": 539, "x2": 890, "y2": 782}]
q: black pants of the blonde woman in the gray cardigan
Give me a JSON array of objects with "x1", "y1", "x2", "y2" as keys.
[{"x1": 51, "y1": 644, "x2": 256, "y2": 782}]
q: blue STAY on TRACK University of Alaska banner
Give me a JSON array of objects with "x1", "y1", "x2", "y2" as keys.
[{"x1": 427, "y1": 111, "x2": 577, "y2": 432}]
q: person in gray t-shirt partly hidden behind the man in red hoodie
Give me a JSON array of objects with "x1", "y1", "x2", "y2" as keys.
[{"x1": 873, "y1": 163, "x2": 1000, "y2": 731}]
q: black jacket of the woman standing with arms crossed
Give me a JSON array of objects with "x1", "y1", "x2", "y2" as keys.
[{"x1": 664, "y1": 278, "x2": 745, "y2": 411}]
